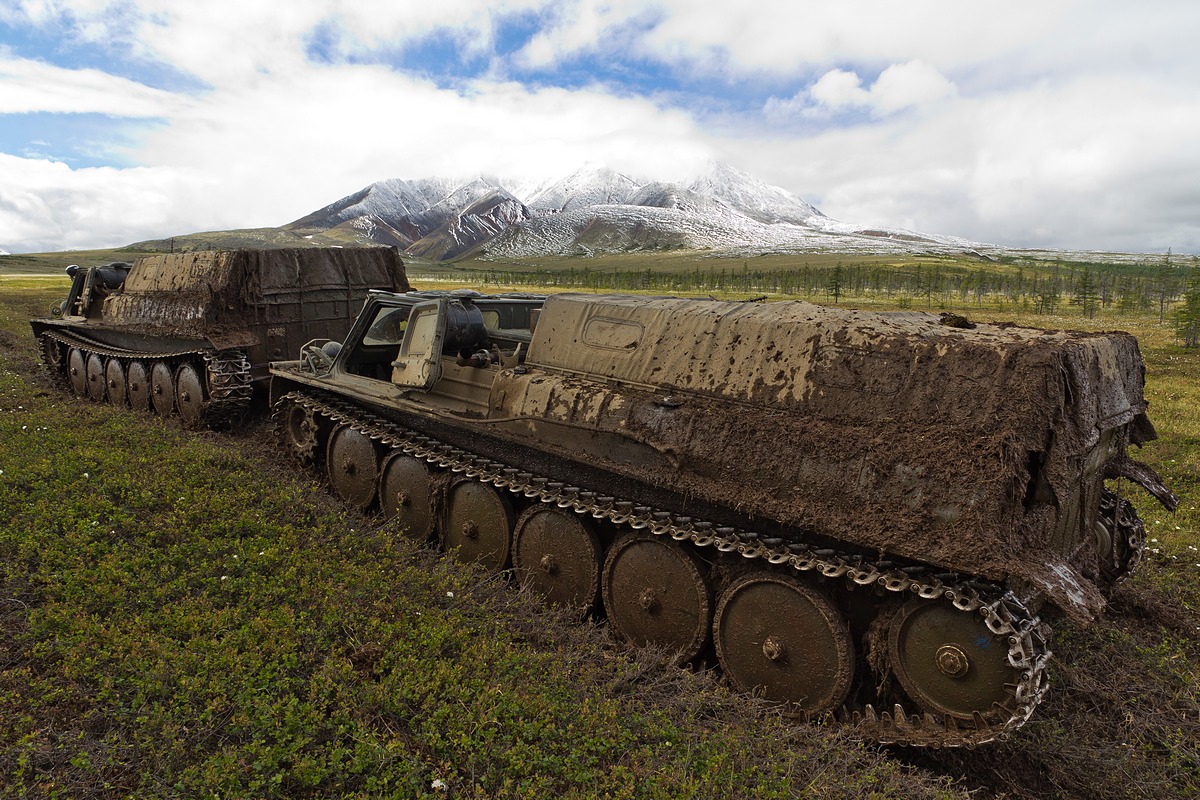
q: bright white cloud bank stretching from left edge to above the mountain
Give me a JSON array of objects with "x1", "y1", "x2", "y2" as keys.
[{"x1": 0, "y1": 65, "x2": 714, "y2": 251}]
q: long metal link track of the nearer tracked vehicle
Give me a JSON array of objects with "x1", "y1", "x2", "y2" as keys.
[{"x1": 275, "y1": 391, "x2": 1051, "y2": 747}]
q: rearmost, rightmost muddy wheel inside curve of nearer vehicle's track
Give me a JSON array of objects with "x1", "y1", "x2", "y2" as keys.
[{"x1": 888, "y1": 599, "x2": 1020, "y2": 720}]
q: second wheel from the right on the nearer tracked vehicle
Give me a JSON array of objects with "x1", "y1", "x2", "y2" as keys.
[{"x1": 713, "y1": 572, "x2": 854, "y2": 716}]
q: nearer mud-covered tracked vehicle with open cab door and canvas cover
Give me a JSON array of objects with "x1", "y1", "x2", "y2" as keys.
[{"x1": 271, "y1": 291, "x2": 1176, "y2": 746}]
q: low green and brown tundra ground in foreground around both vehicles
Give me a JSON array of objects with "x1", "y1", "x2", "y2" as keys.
[{"x1": 0, "y1": 272, "x2": 1200, "y2": 799}]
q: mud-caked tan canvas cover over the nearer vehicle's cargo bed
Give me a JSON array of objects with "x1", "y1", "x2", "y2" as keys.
[{"x1": 504, "y1": 295, "x2": 1171, "y2": 621}]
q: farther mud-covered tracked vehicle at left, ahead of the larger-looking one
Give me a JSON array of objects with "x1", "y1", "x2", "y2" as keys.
[{"x1": 30, "y1": 248, "x2": 409, "y2": 427}]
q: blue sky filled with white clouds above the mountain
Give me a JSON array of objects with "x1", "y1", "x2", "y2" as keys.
[{"x1": 0, "y1": 0, "x2": 1200, "y2": 253}]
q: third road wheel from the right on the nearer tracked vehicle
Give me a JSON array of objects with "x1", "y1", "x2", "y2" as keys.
[{"x1": 601, "y1": 533, "x2": 713, "y2": 663}]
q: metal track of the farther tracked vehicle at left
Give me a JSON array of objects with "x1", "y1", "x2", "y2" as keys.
[{"x1": 41, "y1": 330, "x2": 253, "y2": 426}]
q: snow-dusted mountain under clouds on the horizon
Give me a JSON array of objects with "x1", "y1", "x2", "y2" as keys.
[{"x1": 284, "y1": 163, "x2": 972, "y2": 260}]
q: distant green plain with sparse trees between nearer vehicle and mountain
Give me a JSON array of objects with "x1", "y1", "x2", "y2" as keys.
[{"x1": 420, "y1": 251, "x2": 1198, "y2": 335}]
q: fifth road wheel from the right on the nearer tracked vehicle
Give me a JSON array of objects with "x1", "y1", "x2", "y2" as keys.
[{"x1": 442, "y1": 480, "x2": 512, "y2": 572}]
